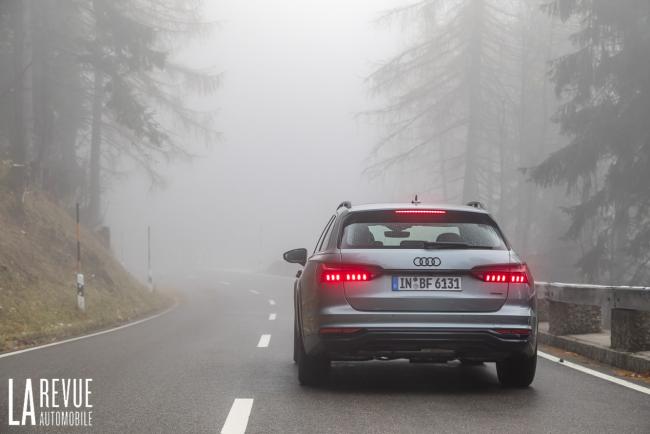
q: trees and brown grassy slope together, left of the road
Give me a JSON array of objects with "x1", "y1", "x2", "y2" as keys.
[{"x1": 0, "y1": 0, "x2": 219, "y2": 351}]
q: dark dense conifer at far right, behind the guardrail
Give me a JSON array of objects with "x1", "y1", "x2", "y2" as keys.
[{"x1": 532, "y1": 0, "x2": 650, "y2": 284}]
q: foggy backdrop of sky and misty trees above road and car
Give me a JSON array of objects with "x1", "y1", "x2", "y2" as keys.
[{"x1": 0, "y1": 0, "x2": 650, "y2": 284}]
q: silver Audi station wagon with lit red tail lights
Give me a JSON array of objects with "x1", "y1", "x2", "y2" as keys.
[{"x1": 284, "y1": 202, "x2": 537, "y2": 387}]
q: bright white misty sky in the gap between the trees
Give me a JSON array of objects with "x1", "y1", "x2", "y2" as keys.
[{"x1": 106, "y1": 0, "x2": 408, "y2": 278}]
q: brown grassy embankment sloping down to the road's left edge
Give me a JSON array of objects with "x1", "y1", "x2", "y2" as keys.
[{"x1": 0, "y1": 189, "x2": 172, "y2": 352}]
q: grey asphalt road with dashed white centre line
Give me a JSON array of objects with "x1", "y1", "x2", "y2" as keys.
[{"x1": 0, "y1": 272, "x2": 650, "y2": 433}]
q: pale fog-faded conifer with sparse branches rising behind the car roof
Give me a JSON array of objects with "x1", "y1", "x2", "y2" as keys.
[{"x1": 369, "y1": 0, "x2": 516, "y2": 207}]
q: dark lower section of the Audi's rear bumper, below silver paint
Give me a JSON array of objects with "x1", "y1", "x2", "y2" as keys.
[{"x1": 310, "y1": 327, "x2": 536, "y2": 362}]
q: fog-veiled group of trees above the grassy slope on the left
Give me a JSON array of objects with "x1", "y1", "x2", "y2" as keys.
[{"x1": 0, "y1": 0, "x2": 219, "y2": 226}]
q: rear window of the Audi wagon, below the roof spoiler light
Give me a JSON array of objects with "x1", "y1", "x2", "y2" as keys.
[{"x1": 339, "y1": 210, "x2": 507, "y2": 250}]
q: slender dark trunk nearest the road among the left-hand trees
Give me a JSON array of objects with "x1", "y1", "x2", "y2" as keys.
[{"x1": 88, "y1": 68, "x2": 104, "y2": 226}]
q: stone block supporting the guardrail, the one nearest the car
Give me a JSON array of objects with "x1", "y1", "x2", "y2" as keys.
[{"x1": 548, "y1": 300, "x2": 601, "y2": 335}]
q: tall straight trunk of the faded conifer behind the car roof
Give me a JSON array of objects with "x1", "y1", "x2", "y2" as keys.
[{"x1": 463, "y1": 0, "x2": 485, "y2": 201}]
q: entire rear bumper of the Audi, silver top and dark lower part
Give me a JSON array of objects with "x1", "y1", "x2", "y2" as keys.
[{"x1": 302, "y1": 302, "x2": 537, "y2": 361}]
